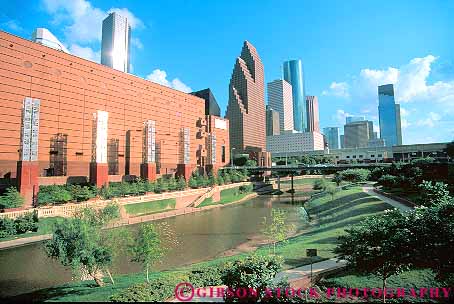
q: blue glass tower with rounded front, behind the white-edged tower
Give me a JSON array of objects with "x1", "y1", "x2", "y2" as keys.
[{"x1": 283, "y1": 59, "x2": 307, "y2": 132}]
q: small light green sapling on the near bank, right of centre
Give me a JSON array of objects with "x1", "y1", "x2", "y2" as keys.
[{"x1": 262, "y1": 209, "x2": 295, "y2": 254}]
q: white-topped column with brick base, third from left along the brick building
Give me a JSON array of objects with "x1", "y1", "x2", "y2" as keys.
[{"x1": 140, "y1": 120, "x2": 156, "y2": 181}]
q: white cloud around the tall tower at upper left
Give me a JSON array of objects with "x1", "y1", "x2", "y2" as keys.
[{"x1": 42, "y1": 0, "x2": 145, "y2": 62}]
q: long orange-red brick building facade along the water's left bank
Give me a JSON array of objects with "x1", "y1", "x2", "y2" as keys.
[{"x1": 0, "y1": 32, "x2": 230, "y2": 205}]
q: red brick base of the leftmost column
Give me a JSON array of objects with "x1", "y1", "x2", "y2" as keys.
[{"x1": 16, "y1": 161, "x2": 39, "y2": 209}]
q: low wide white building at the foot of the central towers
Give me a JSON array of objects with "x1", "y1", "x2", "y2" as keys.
[{"x1": 266, "y1": 131, "x2": 324, "y2": 153}]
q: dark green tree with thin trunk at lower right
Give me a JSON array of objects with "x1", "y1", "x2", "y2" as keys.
[{"x1": 334, "y1": 209, "x2": 413, "y2": 302}]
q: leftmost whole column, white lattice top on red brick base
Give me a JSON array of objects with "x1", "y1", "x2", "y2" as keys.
[{"x1": 17, "y1": 97, "x2": 40, "y2": 208}]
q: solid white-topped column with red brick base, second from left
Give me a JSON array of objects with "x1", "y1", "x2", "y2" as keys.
[{"x1": 90, "y1": 110, "x2": 109, "y2": 188}]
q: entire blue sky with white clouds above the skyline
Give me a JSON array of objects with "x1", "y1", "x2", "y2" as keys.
[{"x1": 0, "y1": 0, "x2": 454, "y2": 144}]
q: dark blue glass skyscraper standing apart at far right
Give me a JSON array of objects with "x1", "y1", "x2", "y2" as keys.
[{"x1": 378, "y1": 84, "x2": 402, "y2": 146}]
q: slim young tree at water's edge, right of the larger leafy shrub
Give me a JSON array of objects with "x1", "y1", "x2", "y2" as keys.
[{"x1": 131, "y1": 224, "x2": 164, "y2": 282}]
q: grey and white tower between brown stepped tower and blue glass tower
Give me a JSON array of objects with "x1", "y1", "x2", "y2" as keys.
[{"x1": 267, "y1": 79, "x2": 293, "y2": 131}]
